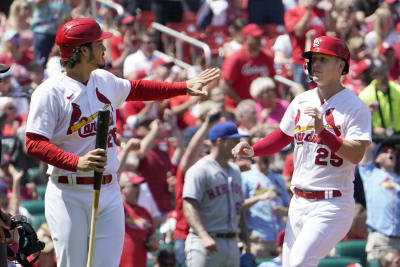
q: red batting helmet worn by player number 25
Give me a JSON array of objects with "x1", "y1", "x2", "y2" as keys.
[{"x1": 302, "y1": 36, "x2": 350, "y2": 75}]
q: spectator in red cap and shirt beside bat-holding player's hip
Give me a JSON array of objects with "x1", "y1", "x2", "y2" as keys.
[{"x1": 119, "y1": 172, "x2": 159, "y2": 267}]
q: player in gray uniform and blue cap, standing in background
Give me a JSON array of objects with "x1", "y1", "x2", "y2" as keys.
[{"x1": 183, "y1": 122, "x2": 247, "y2": 267}]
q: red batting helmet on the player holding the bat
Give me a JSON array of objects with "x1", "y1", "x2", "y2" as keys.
[{"x1": 56, "y1": 18, "x2": 112, "y2": 60}]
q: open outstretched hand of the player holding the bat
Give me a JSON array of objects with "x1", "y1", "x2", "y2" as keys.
[{"x1": 186, "y1": 68, "x2": 220, "y2": 96}]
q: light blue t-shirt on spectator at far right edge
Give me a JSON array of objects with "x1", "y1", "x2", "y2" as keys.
[{"x1": 359, "y1": 161, "x2": 400, "y2": 237}]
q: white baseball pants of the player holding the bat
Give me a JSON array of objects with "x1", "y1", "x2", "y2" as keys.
[{"x1": 45, "y1": 179, "x2": 125, "y2": 267}]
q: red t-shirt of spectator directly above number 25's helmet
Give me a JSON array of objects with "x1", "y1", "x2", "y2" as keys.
[{"x1": 284, "y1": 6, "x2": 325, "y2": 65}]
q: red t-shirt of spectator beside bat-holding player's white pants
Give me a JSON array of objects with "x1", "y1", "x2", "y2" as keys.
[{"x1": 119, "y1": 202, "x2": 155, "y2": 267}]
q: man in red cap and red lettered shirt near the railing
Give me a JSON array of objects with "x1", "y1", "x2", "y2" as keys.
[{"x1": 220, "y1": 24, "x2": 275, "y2": 109}]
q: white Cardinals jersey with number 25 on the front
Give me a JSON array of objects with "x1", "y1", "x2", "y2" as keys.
[{"x1": 280, "y1": 89, "x2": 371, "y2": 194}]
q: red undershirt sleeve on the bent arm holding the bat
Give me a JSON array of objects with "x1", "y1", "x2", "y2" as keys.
[{"x1": 25, "y1": 132, "x2": 79, "y2": 172}]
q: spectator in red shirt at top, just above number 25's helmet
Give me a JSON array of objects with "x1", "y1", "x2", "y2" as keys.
[{"x1": 284, "y1": 0, "x2": 325, "y2": 90}]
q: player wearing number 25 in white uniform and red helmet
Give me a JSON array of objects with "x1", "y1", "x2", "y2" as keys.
[{"x1": 232, "y1": 36, "x2": 371, "y2": 267}]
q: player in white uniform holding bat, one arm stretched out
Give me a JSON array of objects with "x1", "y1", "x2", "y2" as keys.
[{"x1": 26, "y1": 18, "x2": 219, "y2": 267}]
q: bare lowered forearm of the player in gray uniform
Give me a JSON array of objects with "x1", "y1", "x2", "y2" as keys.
[{"x1": 183, "y1": 198, "x2": 218, "y2": 255}]
